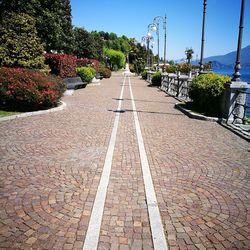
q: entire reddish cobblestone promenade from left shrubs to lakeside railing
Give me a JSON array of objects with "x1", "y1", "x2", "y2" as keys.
[{"x1": 0, "y1": 73, "x2": 250, "y2": 250}]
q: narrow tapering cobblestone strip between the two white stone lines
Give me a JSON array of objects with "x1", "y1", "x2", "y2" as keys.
[{"x1": 99, "y1": 80, "x2": 153, "y2": 250}]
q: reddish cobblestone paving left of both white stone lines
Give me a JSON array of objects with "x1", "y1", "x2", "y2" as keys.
[{"x1": 0, "y1": 78, "x2": 120, "y2": 249}]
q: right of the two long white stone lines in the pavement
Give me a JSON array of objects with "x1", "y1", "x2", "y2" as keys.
[{"x1": 128, "y1": 77, "x2": 168, "y2": 250}]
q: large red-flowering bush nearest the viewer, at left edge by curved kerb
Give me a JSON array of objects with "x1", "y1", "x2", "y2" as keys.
[{"x1": 0, "y1": 67, "x2": 65, "y2": 111}]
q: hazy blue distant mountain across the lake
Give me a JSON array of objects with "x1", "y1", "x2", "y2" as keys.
[{"x1": 204, "y1": 45, "x2": 250, "y2": 68}]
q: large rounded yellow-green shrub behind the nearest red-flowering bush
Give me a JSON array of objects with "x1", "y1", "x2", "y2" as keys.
[{"x1": 0, "y1": 13, "x2": 44, "y2": 69}]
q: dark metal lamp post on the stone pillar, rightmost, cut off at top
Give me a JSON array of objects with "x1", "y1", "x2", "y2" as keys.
[{"x1": 232, "y1": 0, "x2": 245, "y2": 82}]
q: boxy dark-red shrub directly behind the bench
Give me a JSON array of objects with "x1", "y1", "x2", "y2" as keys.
[{"x1": 45, "y1": 54, "x2": 77, "y2": 77}]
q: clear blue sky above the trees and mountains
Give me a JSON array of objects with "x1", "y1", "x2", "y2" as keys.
[{"x1": 71, "y1": 0, "x2": 250, "y2": 60}]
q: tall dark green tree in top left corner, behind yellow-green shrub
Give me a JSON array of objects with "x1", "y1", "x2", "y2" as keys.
[{"x1": 0, "y1": 0, "x2": 73, "y2": 53}]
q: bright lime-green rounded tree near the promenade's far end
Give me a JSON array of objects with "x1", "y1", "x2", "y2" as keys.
[{"x1": 104, "y1": 48, "x2": 125, "y2": 70}]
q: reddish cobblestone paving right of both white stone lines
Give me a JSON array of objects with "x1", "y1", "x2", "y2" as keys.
[{"x1": 132, "y1": 77, "x2": 250, "y2": 249}]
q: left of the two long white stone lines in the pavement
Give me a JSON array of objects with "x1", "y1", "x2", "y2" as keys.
[{"x1": 83, "y1": 77, "x2": 125, "y2": 250}]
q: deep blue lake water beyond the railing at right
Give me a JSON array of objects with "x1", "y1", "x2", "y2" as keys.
[{"x1": 213, "y1": 68, "x2": 250, "y2": 117}]
